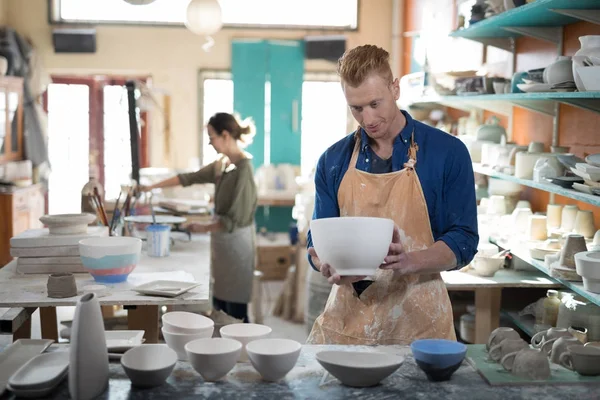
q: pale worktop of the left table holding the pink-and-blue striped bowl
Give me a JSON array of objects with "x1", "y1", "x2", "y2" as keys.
[{"x1": 0, "y1": 234, "x2": 210, "y2": 307}]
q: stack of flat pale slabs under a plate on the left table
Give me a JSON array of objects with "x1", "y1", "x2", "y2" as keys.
[{"x1": 10, "y1": 226, "x2": 108, "y2": 274}]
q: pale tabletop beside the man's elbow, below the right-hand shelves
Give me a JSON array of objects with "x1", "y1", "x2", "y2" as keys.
[{"x1": 442, "y1": 269, "x2": 561, "y2": 290}]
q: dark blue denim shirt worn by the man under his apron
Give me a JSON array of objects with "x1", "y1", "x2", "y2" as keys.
[{"x1": 307, "y1": 111, "x2": 479, "y2": 268}]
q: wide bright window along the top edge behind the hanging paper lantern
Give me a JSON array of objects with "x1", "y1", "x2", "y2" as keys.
[{"x1": 49, "y1": 0, "x2": 358, "y2": 30}]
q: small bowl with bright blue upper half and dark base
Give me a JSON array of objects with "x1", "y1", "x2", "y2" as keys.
[{"x1": 410, "y1": 339, "x2": 467, "y2": 381}]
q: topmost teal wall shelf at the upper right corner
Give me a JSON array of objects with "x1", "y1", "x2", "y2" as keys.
[{"x1": 450, "y1": 0, "x2": 600, "y2": 51}]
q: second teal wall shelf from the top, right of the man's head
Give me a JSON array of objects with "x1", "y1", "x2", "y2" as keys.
[{"x1": 411, "y1": 93, "x2": 600, "y2": 116}]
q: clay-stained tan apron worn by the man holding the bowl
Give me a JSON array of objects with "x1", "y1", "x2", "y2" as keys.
[{"x1": 307, "y1": 132, "x2": 456, "y2": 345}]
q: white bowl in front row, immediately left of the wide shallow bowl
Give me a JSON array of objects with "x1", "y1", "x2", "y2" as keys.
[{"x1": 246, "y1": 339, "x2": 302, "y2": 382}]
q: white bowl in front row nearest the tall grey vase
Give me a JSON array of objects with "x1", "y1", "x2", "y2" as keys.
[{"x1": 121, "y1": 344, "x2": 177, "y2": 387}]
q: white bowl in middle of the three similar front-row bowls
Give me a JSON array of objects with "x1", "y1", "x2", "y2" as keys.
[{"x1": 185, "y1": 338, "x2": 242, "y2": 382}]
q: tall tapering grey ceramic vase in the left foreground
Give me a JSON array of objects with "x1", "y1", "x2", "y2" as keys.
[{"x1": 69, "y1": 293, "x2": 108, "y2": 400}]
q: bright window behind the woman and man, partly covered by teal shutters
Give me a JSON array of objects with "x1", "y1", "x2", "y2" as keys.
[{"x1": 200, "y1": 72, "x2": 348, "y2": 177}]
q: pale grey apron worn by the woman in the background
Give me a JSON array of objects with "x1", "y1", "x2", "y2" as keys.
[{"x1": 210, "y1": 156, "x2": 256, "y2": 304}]
